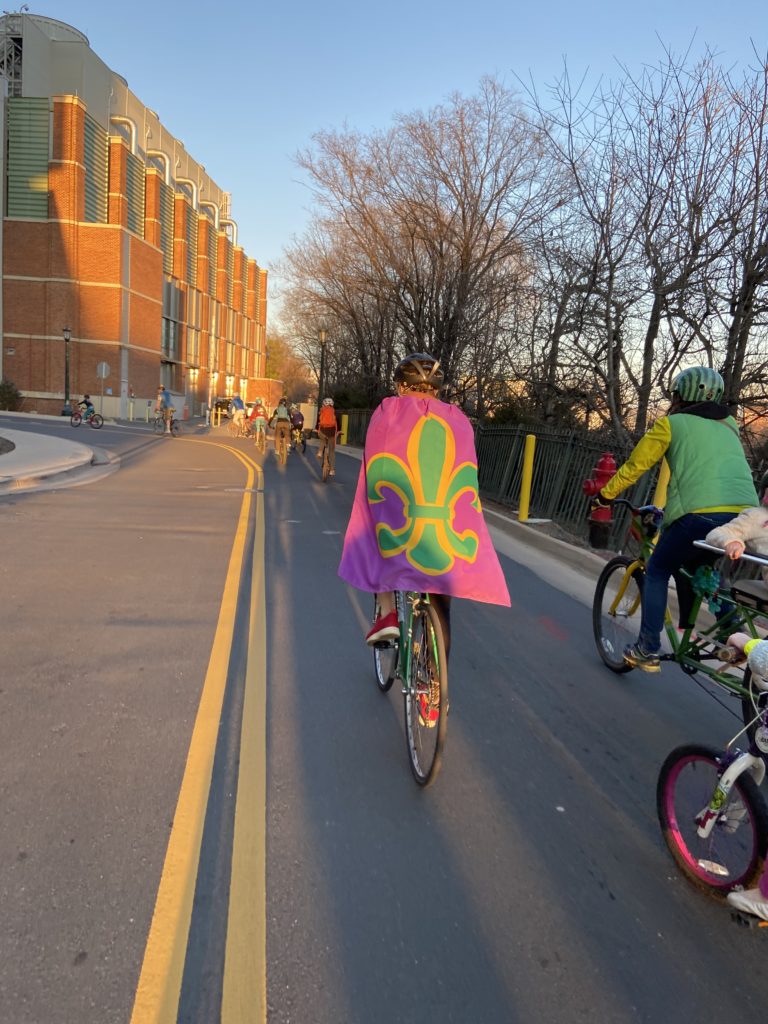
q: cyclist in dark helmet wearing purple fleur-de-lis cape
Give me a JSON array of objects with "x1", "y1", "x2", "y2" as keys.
[{"x1": 339, "y1": 352, "x2": 510, "y2": 675}]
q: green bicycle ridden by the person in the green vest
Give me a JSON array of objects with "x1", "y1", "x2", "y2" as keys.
[{"x1": 592, "y1": 498, "x2": 768, "y2": 739}]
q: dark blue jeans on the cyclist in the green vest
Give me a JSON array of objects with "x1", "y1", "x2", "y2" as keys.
[{"x1": 638, "y1": 512, "x2": 736, "y2": 654}]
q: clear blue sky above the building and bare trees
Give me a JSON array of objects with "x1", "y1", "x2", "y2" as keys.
[{"x1": 34, "y1": 0, "x2": 768, "y2": 319}]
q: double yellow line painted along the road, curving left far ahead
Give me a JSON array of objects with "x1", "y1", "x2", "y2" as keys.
[{"x1": 131, "y1": 441, "x2": 266, "y2": 1024}]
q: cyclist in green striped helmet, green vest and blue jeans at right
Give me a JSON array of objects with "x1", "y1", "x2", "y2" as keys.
[{"x1": 592, "y1": 367, "x2": 758, "y2": 672}]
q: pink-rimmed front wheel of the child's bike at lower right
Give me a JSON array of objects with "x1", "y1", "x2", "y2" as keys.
[{"x1": 656, "y1": 744, "x2": 768, "y2": 897}]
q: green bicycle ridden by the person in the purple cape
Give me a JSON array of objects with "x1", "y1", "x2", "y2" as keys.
[{"x1": 373, "y1": 591, "x2": 449, "y2": 785}]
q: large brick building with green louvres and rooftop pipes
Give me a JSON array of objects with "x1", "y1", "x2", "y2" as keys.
[{"x1": 0, "y1": 13, "x2": 281, "y2": 418}]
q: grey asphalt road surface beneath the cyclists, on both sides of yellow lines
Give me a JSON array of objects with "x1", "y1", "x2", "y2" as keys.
[{"x1": 0, "y1": 425, "x2": 766, "y2": 1024}]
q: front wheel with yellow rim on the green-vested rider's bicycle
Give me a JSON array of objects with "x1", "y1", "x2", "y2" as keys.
[{"x1": 592, "y1": 555, "x2": 644, "y2": 673}]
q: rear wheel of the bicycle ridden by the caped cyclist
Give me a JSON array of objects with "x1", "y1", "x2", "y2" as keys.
[{"x1": 404, "y1": 601, "x2": 447, "y2": 785}]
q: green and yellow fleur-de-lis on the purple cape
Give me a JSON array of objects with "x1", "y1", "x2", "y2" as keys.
[{"x1": 366, "y1": 413, "x2": 480, "y2": 575}]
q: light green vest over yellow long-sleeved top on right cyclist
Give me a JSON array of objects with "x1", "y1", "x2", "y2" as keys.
[{"x1": 601, "y1": 401, "x2": 758, "y2": 526}]
